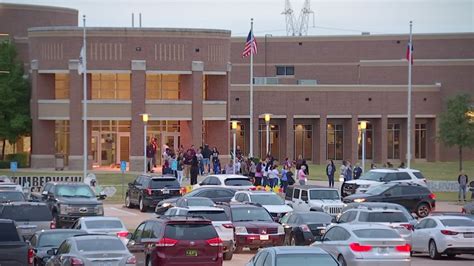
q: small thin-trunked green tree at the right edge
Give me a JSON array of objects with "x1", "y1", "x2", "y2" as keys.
[{"x1": 439, "y1": 94, "x2": 474, "y2": 170}]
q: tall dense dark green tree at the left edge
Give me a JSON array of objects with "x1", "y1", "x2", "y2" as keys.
[{"x1": 0, "y1": 41, "x2": 31, "y2": 160}]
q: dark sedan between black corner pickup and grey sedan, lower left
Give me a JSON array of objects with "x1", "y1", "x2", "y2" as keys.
[{"x1": 30, "y1": 229, "x2": 87, "y2": 266}]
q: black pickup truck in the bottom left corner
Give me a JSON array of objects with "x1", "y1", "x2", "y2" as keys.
[{"x1": 0, "y1": 219, "x2": 33, "y2": 266}]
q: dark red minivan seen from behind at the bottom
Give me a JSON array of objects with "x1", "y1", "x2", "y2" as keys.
[{"x1": 127, "y1": 216, "x2": 223, "y2": 266}]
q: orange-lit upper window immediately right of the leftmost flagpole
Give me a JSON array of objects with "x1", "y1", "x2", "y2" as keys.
[{"x1": 91, "y1": 73, "x2": 131, "y2": 100}]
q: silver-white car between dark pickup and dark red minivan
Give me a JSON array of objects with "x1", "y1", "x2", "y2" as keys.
[{"x1": 71, "y1": 216, "x2": 129, "y2": 244}]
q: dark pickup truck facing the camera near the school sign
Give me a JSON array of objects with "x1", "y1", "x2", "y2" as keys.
[{"x1": 31, "y1": 182, "x2": 105, "y2": 228}]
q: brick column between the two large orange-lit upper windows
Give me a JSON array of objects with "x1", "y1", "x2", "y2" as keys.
[{"x1": 130, "y1": 60, "x2": 146, "y2": 172}]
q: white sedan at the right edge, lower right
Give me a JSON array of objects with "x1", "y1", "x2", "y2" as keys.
[{"x1": 412, "y1": 216, "x2": 474, "y2": 259}]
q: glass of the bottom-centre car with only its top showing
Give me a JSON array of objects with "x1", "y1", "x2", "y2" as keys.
[{"x1": 276, "y1": 253, "x2": 339, "y2": 266}]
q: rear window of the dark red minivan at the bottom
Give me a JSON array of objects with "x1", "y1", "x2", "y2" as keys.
[{"x1": 165, "y1": 224, "x2": 217, "y2": 240}]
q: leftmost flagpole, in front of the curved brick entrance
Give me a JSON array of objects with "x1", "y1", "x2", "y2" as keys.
[{"x1": 82, "y1": 15, "x2": 88, "y2": 180}]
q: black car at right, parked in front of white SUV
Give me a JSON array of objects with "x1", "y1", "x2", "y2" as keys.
[{"x1": 343, "y1": 183, "x2": 436, "y2": 217}]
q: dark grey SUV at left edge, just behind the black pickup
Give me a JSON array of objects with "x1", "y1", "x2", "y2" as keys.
[{"x1": 0, "y1": 202, "x2": 56, "y2": 240}]
